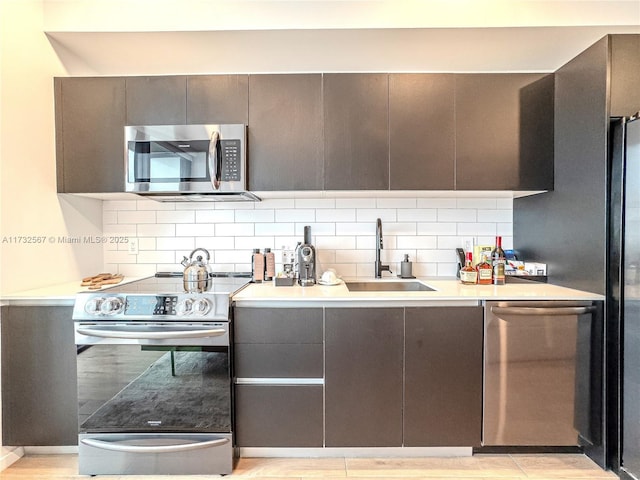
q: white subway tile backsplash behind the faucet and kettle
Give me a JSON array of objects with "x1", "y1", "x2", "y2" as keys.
[{"x1": 102, "y1": 195, "x2": 513, "y2": 278}]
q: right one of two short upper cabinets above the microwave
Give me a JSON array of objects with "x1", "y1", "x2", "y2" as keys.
[{"x1": 187, "y1": 75, "x2": 249, "y2": 125}]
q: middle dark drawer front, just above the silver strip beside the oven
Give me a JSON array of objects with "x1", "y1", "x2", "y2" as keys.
[{"x1": 234, "y1": 344, "x2": 323, "y2": 378}]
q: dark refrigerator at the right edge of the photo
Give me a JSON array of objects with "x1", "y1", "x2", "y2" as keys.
[{"x1": 607, "y1": 115, "x2": 640, "y2": 479}]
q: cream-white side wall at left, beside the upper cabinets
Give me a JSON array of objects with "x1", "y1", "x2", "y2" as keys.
[{"x1": 0, "y1": 0, "x2": 102, "y2": 294}]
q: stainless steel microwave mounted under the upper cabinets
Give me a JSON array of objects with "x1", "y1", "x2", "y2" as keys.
[{"x1": 125, "y1": 124, "x2": 260, "y2": 201}]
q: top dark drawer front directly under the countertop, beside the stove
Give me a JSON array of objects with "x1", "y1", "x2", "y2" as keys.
[{"x1": 234, "y1": 307, "x2": 322, "y2": 344}]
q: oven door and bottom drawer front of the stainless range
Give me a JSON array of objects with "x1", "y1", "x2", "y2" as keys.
[{"x1": 75, "y1": 322, "x2": 233, "y2": 475}]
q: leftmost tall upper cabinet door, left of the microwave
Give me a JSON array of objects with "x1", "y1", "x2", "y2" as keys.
[{"x1": 54, "y1": 77, "x2": 125, "y2": 193}]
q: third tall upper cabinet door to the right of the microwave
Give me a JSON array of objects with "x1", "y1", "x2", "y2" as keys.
[{"x1": 389, "y1": 74, "x2": 455, "y2": 190}]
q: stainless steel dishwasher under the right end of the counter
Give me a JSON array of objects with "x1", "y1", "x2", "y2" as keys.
[{"x1": 483, "y1": 301, "x2": 595, "y2": 446}]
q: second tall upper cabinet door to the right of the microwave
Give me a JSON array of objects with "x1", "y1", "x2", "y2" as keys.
[{"x1": 323, "y1": 73, "x2": 389, "y2": 190}]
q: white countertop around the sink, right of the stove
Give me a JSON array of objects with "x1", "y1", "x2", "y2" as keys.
[{"x1": 234, "y1": 277, "x2": 604, "y2": 306}]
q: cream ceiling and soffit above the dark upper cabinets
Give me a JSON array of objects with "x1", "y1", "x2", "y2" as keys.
[{"x1": 43, "y1": 0, "x2": 640, "y2": 75}]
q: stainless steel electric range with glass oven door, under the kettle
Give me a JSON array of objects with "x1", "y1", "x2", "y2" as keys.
[{"x1": 73, "y1": 274, "x2": 248, "y2": 475}]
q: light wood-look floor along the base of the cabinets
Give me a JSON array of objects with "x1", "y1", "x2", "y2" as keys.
[{"x1": 0, "y1": 454, "x2": 618, "y2": 480}]
